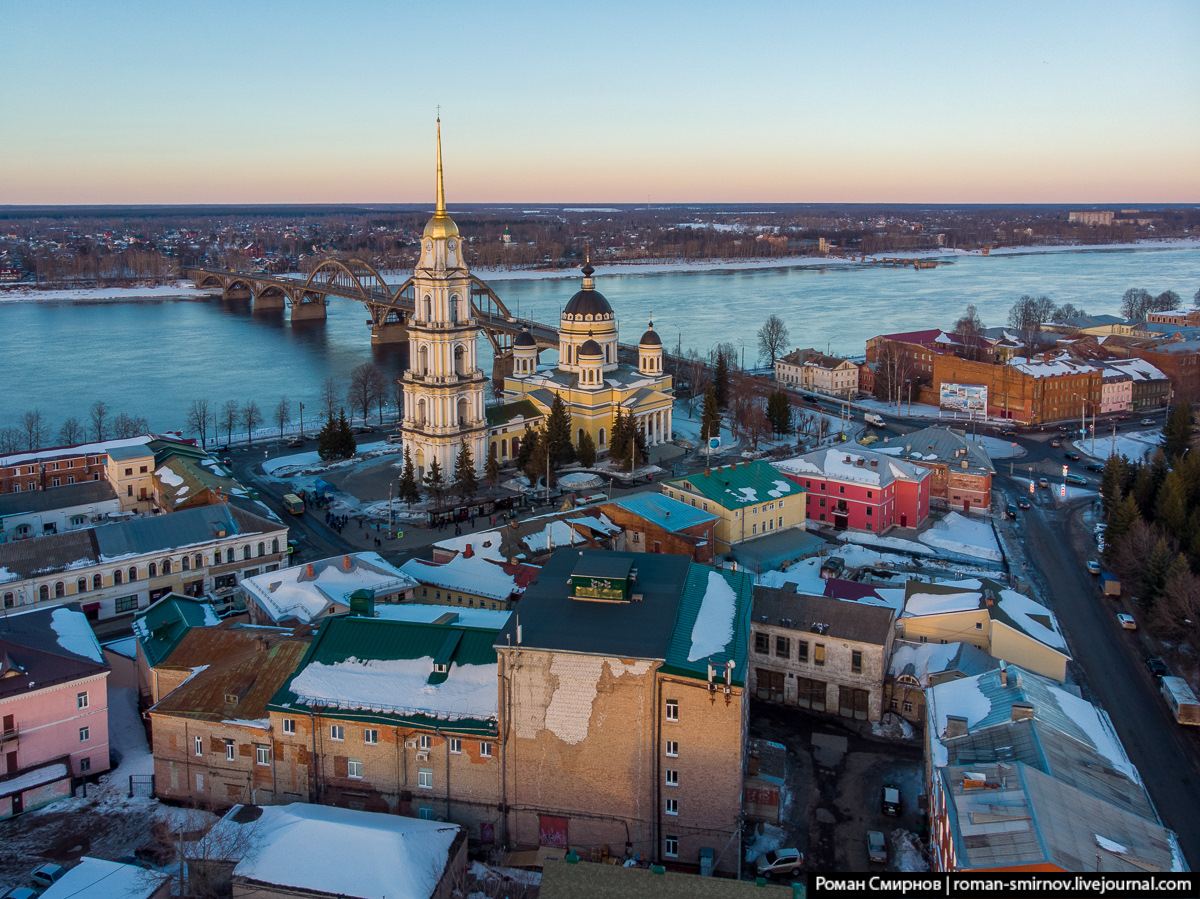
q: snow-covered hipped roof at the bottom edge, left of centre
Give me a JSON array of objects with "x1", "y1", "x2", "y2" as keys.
[{"x1": 210, "y1": 803, "x2": 458, "y2": 899}]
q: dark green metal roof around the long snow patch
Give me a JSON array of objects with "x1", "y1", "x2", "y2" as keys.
[{"x1": 266, "y1": 616, "x2": 499, "y2": 736}]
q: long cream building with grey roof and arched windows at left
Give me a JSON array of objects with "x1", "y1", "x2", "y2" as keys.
[{"x1": 0, "y1": 503, "x2": 288, "y2": 619}]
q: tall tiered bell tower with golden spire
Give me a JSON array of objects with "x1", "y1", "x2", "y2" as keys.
[{"x1": 400, "y1": 123, "x2": 487, "y2": 483}]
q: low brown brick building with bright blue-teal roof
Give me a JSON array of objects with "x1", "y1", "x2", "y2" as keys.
[{"x1": 598, "y1": 493, "x2": 719, "y2": 563}]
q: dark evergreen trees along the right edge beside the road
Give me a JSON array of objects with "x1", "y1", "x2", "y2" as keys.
[{"x1": 1100, "y1": 403, "x2": 1200, "y2": 641}]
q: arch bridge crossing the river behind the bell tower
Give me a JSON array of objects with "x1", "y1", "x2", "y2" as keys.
[{"x1": 182, "y1": 259, "x2": 558, "y2": 360}]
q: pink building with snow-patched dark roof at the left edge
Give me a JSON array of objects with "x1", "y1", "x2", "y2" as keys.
[{"x1": 0, "y1": 603, "x2": 108, "y2": 792}]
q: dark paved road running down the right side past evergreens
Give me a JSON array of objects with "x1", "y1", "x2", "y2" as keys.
[{"x1": 1003, "y1": 478, "x2": 1200, "y2": 868}]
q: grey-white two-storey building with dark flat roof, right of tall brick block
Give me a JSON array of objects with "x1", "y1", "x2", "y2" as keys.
[{"x1": 749, "y1": 587, "x2": 895, "y2": 721}]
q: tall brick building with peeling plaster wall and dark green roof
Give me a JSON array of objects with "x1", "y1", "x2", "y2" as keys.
[{"x1": 496, "y1": 550, "x2": 752, "y2": 871}]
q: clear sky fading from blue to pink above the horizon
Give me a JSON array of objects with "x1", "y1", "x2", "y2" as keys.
[{"x1": 0, "y1": 0, "x2": 1200, "y2": 210}]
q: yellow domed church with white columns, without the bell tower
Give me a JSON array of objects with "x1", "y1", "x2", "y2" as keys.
[{"x1": 504, "y1": 263, "x2": 674, "y2": 451}]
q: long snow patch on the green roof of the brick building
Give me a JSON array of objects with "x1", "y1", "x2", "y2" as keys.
[{"x1": 292, "y1": 655, "x2": 497, "y2": 720}]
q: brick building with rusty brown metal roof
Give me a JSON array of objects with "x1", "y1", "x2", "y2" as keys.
[{"x1": 146, "y1": 624, "x2": 311, "y2": 809}]
